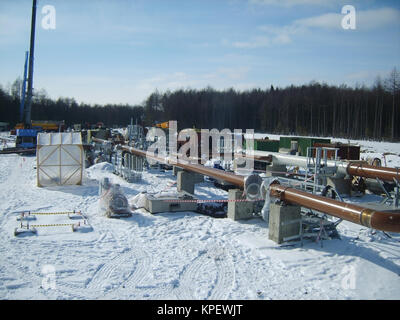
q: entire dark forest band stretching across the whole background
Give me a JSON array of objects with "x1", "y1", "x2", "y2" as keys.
[{"x1": 0, "y1": 68, "x2": 400, "y2": 141}]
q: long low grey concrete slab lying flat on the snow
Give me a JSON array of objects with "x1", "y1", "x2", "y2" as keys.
[{"x1": 145, "y1": 195, "x2": 197, "y2": 214}]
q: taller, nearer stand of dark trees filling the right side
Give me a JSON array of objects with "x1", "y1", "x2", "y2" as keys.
[{"x1": 144, "y1": 69, "x2": 400, "y2": 140}]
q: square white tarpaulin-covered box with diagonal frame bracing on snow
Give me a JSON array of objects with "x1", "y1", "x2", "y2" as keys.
[{"x1": 36, "y1": 132, "x2": 84, "y2": 187}]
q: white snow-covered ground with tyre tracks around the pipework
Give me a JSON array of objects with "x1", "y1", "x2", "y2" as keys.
[{"x1": 0, "y1": 135, "x2": 400, "y2": 300}]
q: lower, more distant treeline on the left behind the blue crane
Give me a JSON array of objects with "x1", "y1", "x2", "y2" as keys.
[{"x1": 0, "y1": 79, "x2": 144, "y2": 127}]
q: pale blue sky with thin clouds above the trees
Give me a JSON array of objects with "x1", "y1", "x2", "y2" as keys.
[{"x1": 0, "y1": 0, "x2": 400, "y2": 104}]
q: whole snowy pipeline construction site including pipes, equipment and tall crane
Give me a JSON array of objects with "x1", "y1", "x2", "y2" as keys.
[{"x1": 0, "y1": 1, "x2": 400, "y2": 300}]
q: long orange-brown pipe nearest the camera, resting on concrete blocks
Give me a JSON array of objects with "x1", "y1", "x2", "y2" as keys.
[{"x1": 121, "y1": 146, "x2": 400, "y2": 233}]
